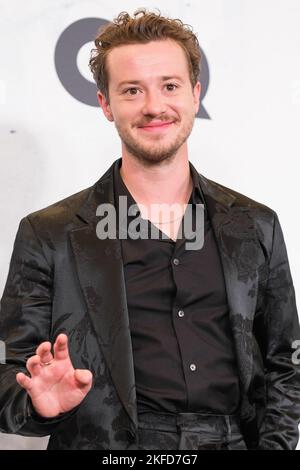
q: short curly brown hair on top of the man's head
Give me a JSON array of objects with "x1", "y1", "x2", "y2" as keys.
[{"x1": 89, "y1": 8, "x2": 201, "y2": 102}]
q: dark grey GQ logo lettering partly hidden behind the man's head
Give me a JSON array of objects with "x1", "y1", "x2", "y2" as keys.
[{"x1": 55, "y1": 18, "x2": 210, "y2": 119}]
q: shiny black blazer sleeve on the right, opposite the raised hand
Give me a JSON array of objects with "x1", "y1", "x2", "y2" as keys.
[{"x1": 259, "y1": 214, "x2": 300, "y2": 450}]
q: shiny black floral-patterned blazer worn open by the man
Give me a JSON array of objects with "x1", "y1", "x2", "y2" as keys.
[{"x1": 0, "y1": 161, "x2": 300, "y2": 449}]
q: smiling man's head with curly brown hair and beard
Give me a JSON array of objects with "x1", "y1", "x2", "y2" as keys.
[{"x1": 90, "y1": 9, "x2": 201, "y2": 164}]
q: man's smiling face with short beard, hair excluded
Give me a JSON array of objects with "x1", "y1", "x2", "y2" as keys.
[{"x1": 98, "y1": 39, "x2": 201, "y2": 165}]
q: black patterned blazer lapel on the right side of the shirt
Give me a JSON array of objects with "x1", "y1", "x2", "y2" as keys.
[{"x1": 199, "y1": 175, "x2": 263, "y2": 392}]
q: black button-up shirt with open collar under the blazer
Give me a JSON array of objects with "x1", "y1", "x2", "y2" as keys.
[{"x1": 114, "y1": 161, "x2": 239, "y2": 414}]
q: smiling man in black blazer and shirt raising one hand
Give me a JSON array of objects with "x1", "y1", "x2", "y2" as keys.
[{"x1": 0, "y1": 6, "x2": 300, "y2": 450}]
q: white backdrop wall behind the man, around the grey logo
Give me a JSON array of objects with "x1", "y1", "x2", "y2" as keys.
[{"x1": 0, "y1": 0, "x2": 300, "y2": 449}]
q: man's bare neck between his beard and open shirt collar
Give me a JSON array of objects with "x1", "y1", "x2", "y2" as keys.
[{"x1": 120, "y1": 156, "x2": 193, "y2": 206}]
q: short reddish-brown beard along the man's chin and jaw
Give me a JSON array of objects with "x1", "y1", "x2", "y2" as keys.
[{"x1": 115, "y1": 115, "x2": 195, "y2": 166}]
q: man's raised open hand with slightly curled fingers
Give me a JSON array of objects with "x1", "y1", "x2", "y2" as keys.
[{"x1": 16, "y1": 334, "x2": 93, "y2": 418}]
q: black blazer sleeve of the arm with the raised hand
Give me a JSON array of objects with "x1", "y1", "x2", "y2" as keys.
[{"x1": 0, "y1": 217, "x2": 77, "y2": 436}]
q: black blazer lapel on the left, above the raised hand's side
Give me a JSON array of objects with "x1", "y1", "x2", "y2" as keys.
[{"x1": 70, "y1": 164, "x2": 137, "y2": 427}]
